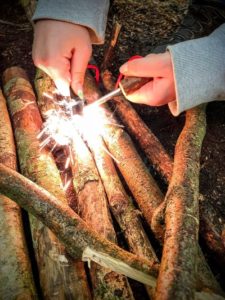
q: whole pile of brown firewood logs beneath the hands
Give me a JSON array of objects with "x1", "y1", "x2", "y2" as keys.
[{"x1": 0, "y1": 0, "x2": 225, "y2": 300}]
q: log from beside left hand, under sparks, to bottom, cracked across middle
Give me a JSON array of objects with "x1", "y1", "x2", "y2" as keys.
[{"x1": 35, "y1": 70, "x2": 133, "y2": 299}]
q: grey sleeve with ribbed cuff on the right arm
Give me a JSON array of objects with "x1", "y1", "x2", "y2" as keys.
[{"x1": 167, "y1": 24, "x2": 225, "y2": 116}]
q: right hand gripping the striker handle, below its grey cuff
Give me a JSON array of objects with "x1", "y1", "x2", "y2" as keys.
[{"x1": 120, "y1": 52, "x2": 176, "y2": 106}]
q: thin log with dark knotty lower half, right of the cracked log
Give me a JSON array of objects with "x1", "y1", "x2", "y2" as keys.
[{"x1": 88, "y1": 136, "x2": 158, "y2": 297}]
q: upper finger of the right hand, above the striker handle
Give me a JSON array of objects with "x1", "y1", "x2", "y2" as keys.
[{"x1": 120, "y1": 54, "x2": 167, "y2": 77}]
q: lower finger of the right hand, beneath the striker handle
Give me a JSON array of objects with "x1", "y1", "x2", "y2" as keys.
[{"x1": 127, "y1": 78, "x2": 175, "y2": 106}]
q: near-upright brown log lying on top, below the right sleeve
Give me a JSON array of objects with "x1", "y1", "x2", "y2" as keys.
[{"x1": 155, "y1": 107, "x2": 205, "y2": 300}]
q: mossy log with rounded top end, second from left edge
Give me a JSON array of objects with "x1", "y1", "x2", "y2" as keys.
[{"x1": 3, "y1": 67, "x2": 90, "y2": 299}]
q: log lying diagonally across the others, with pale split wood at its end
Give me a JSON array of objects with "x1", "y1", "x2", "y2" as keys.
[{"x1": 0, "y1": 163, "x2": 158, "y2": 287}]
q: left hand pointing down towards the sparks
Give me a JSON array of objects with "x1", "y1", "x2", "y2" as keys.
[{"x1": 32, "y1": 20, "x2": 92, "y2": 97}]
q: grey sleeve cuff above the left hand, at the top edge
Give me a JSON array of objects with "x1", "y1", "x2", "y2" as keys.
[{"x1": 33, "y1": 0, "x2": 109, "y2": 44}]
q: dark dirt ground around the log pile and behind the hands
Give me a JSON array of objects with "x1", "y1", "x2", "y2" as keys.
[{"x1": 0, "y1": 0, "x2": 225, "y2": 292}]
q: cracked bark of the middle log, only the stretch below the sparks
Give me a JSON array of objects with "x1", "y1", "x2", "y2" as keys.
[{"x1": 72, "y1": 132, "x2": 133, "y2": 299}]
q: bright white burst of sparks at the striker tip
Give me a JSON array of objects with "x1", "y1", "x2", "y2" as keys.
[{"x1": 37, "y1": 93, "x2": 120, "y2": 191}]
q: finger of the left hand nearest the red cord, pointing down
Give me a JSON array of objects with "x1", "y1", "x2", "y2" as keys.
[{"x1": 71, "y1": 46, "x2": 92, "y2": 98}]
